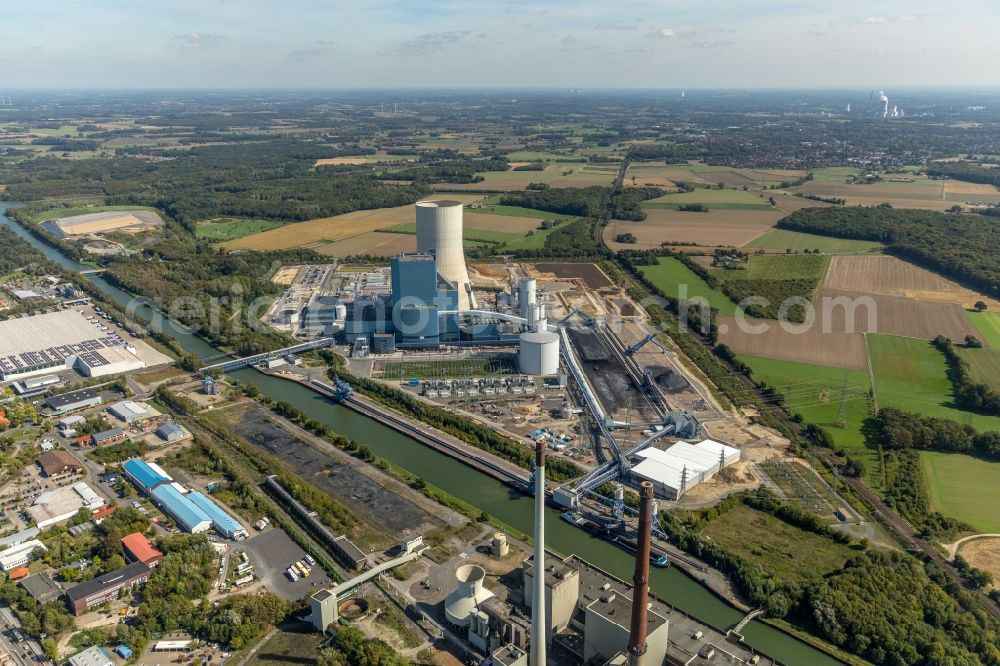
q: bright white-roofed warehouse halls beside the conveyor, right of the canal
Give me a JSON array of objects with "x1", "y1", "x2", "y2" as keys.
[{"x1": 632, "y1": 439, "x2": 740, "y2": 500}]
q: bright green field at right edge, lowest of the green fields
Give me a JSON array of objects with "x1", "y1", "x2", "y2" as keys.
[{"x1": 920, "y1": 451, "x2": 1000, "y2": 534}]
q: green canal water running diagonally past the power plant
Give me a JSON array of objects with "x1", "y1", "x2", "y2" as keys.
[{"x1": 0, "y1": 202, "x2": 841, "y2": 666}]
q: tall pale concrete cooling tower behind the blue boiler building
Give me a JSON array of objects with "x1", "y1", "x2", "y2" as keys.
[{"x1": 417, "y1": 200, "x2": 475, "y2": 310}]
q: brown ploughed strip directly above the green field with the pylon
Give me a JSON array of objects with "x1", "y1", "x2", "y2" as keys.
[{"x1": 717, "y1": 315, "x2": 868, "y2": 372}]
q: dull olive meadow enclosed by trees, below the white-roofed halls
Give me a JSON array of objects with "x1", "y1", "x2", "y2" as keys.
[{"x1": 701, "y1": 506, "x2": 854, "y2": 581}]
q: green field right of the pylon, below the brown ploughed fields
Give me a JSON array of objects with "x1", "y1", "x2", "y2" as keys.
[{"x1": 865, "y1": 333, "x2": 1000, "y2": 431}]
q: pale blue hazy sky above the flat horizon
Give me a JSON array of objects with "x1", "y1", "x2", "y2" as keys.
[{"x1": 0, "y1": 0, "x2": 1000, "y2": 90}]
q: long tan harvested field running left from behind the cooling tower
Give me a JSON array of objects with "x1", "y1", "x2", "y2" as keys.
[{"x1": 223, "y1": 194, "x2": 482, "y2": 250}]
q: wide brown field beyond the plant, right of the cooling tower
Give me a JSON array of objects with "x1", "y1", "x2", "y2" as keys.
[{"x1": 604, "y1": 208, "x2": 784, "y2": 250}]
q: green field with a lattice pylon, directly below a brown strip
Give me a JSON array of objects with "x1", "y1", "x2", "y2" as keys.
[{"x1": 740, "y1": 355, "x2": 871, "y2": 452}]
